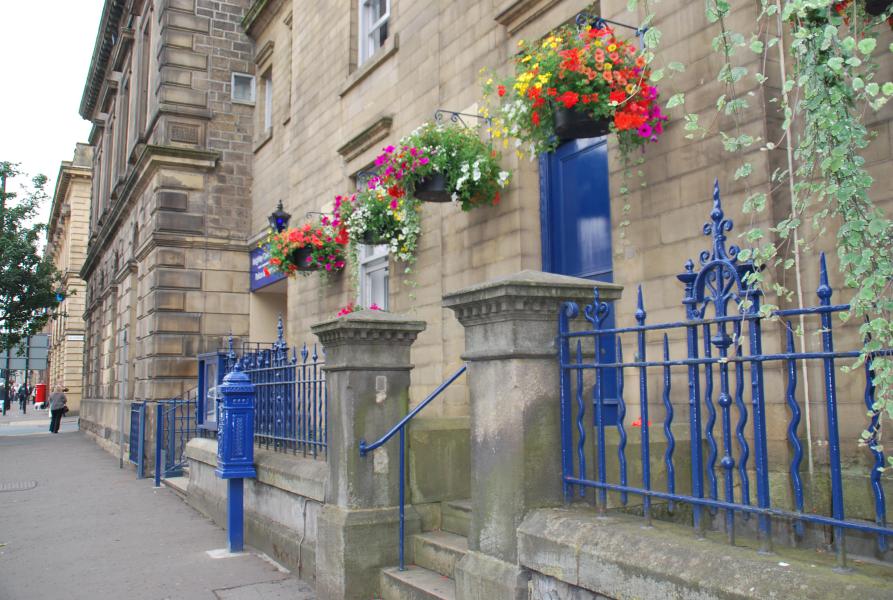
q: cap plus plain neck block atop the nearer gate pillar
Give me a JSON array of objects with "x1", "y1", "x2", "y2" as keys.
[{"x1": 443, "y1": 270, "x2": 623, "y2": 360}]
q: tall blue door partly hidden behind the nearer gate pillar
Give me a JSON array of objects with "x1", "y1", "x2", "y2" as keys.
[{"x1": 540, "y1": 137, "x2": 617, "y2": 425}]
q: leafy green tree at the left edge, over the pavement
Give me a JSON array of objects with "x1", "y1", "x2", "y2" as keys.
[{"x1": 0, "y1": 161, "x2": 60, "y2": 349}]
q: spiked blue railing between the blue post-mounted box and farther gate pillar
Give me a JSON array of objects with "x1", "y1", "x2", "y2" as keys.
[{"x1": 224, "y1": 326, "x2": 328, "y2": 458}]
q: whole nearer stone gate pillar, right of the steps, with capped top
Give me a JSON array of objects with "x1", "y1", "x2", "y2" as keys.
[{"x1": 443, "y1": 271, "x2": 622, "y2": 600}]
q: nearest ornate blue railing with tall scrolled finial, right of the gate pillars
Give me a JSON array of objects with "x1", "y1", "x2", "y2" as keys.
[{"x1": 558, "y1": 185, "x2": 893, "y2": 567}]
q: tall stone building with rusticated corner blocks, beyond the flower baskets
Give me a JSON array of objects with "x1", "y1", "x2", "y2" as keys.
[{"x1": 80, "y1": 0, "x2": 254, "y2": 444}]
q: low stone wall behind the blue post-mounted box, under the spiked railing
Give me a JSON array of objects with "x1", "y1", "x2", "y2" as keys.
[{"x1": 186, "y1": 438, "x2": 327, "y2": 581}]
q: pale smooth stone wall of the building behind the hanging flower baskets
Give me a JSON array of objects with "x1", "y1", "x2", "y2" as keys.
[{"x1": 243, "y1": 0, "x2": 893, "y2": 460}]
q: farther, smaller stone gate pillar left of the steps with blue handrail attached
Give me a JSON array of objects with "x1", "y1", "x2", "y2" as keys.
[{"x1": 311, "y1": 310, "x2": 425, "y2": 600}]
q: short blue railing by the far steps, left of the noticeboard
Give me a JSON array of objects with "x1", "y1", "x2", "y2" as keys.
[{"x1": 155, "y1": 390, "x2": 199, "y2": 487}]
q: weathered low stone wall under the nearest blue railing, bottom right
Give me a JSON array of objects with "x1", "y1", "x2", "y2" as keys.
[{"x1": 518, "y1": 508, "x2": 893, "y2": 600}]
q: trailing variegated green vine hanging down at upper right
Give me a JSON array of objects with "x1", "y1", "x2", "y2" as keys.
[{"x1": 629, "y1": 0, "x2": 893, "y2": 464}]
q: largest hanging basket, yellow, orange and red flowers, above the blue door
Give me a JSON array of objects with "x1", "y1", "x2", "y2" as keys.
[{"x1": 482, "y1": 25, "x2": 667, "y2": 157}]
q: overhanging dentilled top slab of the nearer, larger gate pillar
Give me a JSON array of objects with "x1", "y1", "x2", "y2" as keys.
[{"x1": 443, "y1": 271, "x2": 623, "y2": 327}]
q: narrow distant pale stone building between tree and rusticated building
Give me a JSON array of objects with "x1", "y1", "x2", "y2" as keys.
[{"x1": 46, "y1": 144, "x2": 93, "y2": 414}]
